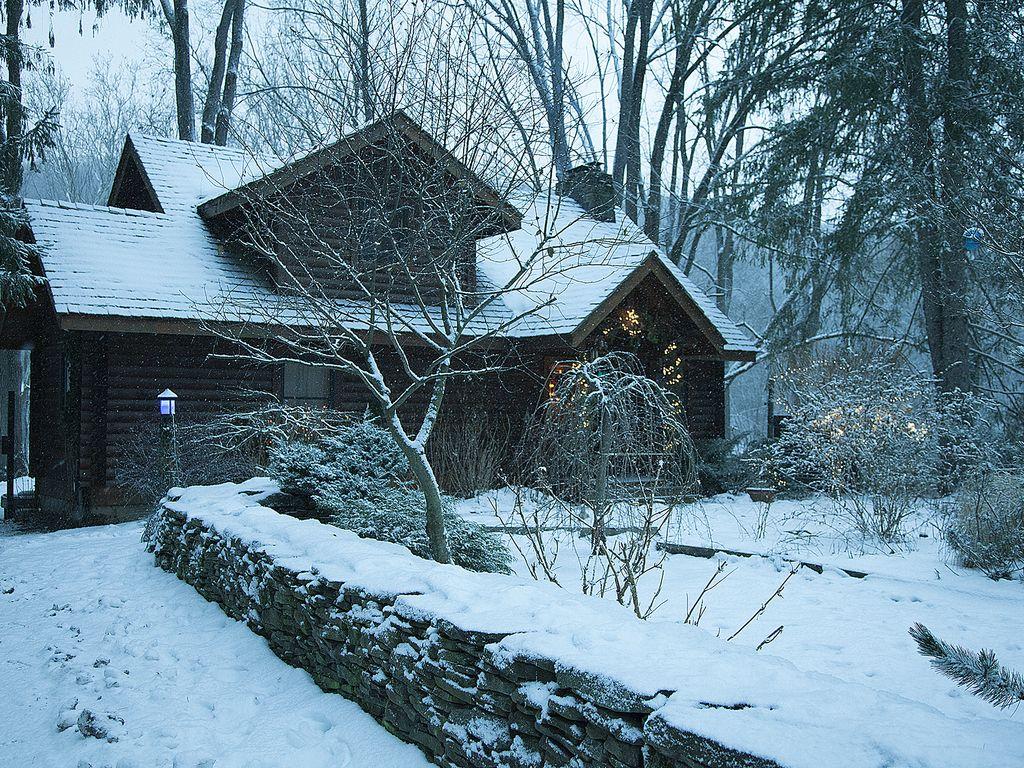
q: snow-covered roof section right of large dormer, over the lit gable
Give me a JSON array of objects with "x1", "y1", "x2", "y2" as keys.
[{"x1": 477, "y1": 193, "x2": 757, "y2": 352}]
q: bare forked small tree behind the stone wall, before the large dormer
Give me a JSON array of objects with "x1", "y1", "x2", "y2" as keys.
[{"x1": 203, "y1": 78, "x2": 634, "y2": 562}]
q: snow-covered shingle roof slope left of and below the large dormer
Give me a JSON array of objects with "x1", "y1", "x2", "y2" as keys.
[{"x1": 25, "y1": 200, "x2": 510, "y2": 335}]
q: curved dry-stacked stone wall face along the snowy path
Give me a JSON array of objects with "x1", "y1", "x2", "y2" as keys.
[{"x1": 148, "y1": 493, "x2": 777, "y2": 768}]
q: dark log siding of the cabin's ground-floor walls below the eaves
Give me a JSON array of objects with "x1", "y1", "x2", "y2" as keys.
[{"x1": 31, "y1": 270, "x2": 726, "y2": 513}]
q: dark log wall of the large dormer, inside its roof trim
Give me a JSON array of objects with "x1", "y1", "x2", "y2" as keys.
[{"x1": 208, "y1": 138, "x2": 497, "y2": 302}]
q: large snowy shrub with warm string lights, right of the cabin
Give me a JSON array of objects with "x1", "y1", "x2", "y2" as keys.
[{"x1": 752, "y1": 353, "x2": 991, "y2": 542}]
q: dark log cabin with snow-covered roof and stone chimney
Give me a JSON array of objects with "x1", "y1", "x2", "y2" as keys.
[{"x1": 0, "y1": 113, "x2": 756, "y2": 521}]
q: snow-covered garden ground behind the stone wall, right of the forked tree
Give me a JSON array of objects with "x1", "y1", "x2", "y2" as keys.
[{"x1": 459, "y1": 489, "x2": 1024, "y2": 745}]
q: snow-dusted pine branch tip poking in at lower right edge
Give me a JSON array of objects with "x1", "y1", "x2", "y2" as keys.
[{"x1": 909, "y1": 624, "x2": 1024, "y2": 709}]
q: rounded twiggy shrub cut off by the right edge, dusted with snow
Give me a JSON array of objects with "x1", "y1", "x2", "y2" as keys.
[{"x1": 945, "y1": 472, "x2": 1024, "y2": 579}]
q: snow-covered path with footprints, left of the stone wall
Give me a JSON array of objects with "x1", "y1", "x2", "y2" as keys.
[{"x1": 0, "y1": 523, "x2": 429, "y2": 768}]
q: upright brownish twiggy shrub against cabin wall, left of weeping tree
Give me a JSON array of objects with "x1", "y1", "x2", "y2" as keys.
[{"x1": 427, "y1": 409, "x2": 512, "y2": 499}]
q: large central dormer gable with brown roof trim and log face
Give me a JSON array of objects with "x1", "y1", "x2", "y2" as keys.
[{"x1": 198, "y1": 113, "x2": 521, "y2": 303}]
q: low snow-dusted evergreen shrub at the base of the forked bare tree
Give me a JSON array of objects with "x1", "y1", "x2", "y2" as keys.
[{"x1": 268, "y1": 421, "x2": 511, "y2": 572}]
